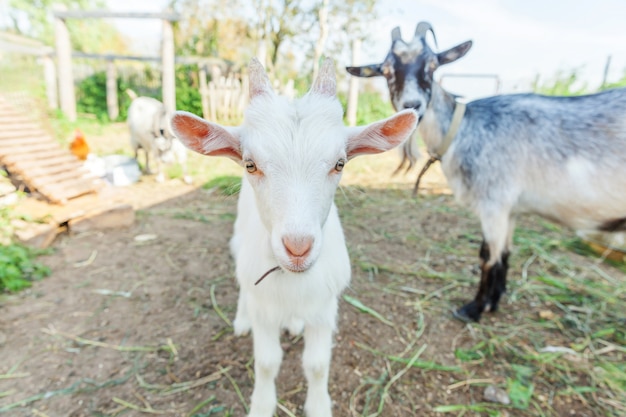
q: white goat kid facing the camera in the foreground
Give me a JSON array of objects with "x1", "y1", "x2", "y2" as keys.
[{"x1": 172, "y1": 60, "x2": 417, "y2": 417}]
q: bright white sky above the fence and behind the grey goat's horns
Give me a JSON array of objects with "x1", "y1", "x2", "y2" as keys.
[{"x1": 107, "y1": 0, "x2": 626, "y2": 97}]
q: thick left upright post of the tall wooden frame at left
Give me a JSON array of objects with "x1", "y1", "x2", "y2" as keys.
[{"x1": 54, "y1": 11, "x2": 76, "y2": 122}]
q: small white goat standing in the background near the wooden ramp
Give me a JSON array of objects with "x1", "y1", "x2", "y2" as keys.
[{"x1": 127, "y1": 97, "x2": 192, "y2": 184}]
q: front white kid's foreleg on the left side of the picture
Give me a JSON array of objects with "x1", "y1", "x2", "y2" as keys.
[{"x1": 248, "y1": 323, "x2": 283, "y2": 417}]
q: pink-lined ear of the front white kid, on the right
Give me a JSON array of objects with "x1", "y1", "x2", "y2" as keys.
[{"x1": 346, "y1": 109, "x2": 417, "y2": 159}]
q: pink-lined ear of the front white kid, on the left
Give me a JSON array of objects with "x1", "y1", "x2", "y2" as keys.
[{"x1": 172, "y1": 111, "x2": 241, "y2": 162}]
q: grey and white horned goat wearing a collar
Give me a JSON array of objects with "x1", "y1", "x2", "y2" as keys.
[{"x1": 347, "y1": 22, "x2": 626, "y2": 321}]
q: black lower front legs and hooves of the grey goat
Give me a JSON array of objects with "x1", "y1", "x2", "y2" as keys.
[{"x1": 454, "y1": 241, "x2": 509, "y2": 321}]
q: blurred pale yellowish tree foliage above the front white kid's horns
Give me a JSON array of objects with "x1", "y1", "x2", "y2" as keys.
[{"x1": 170, "y1": 0, "x2": 378, "y2": 81}]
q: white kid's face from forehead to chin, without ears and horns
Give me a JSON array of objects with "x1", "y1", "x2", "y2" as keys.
[{"x1": 242, "y1": 107, "x2": 347, "y2": 272}]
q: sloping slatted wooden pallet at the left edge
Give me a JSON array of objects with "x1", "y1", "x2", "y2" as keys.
[{"x1": 0, "y1": 96, "x2": 104, "y2": 204}]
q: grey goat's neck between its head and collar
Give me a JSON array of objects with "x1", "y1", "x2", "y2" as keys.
[{"x1": 417, "y1": 83, "x2": 455, "y2": 156}]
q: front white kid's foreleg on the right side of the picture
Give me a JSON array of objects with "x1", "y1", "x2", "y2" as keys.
[{"x1": 302, "y1": 325, "x2": 333, "y2": 417}]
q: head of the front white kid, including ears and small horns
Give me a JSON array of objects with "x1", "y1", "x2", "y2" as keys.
[{"x1": 172, "y1": 60, "x2": 417, "y2": 272}]
